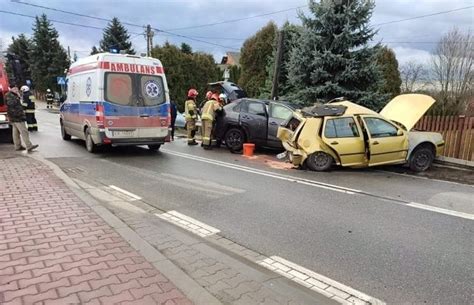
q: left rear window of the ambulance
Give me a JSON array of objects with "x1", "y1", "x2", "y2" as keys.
[{"x1": 105, "y1": 73, "x2": 133, "y2": 105}]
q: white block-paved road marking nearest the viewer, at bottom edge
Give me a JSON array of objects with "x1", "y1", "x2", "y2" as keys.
[{"x1": 257, "y1": 256, "x2": 385, "y2": 305}]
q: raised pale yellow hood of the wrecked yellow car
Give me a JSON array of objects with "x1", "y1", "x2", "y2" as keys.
[{"x1": 380, "y1": 94, "x2": 435, "y2": 130}]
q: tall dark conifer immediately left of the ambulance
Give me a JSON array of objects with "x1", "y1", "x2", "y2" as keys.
[{"x1": 30, "y1": 14, "x2": 69, "y2": 92}]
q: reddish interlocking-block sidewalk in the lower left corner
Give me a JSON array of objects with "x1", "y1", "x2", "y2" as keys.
[{"x1": 0, "y1": 154, "x2": 191, "y2": 305}]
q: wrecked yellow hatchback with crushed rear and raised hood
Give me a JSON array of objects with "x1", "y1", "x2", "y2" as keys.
[{"x1": 278, "y1": 94, "x2": 444, "y2": 172}]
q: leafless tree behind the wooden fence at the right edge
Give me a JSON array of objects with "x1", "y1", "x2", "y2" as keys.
[{"x1": 431, "y1": 28, "x2": 474, "y2": 114}]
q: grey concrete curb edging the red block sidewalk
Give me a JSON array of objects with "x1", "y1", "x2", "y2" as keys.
[{"x1": 28, "y1": 155, "x2": 222, "y2": 305}]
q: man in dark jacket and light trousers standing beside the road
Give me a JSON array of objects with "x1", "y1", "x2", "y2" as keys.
[{"x1": 5, "y1": 85, "x2": 38, "y2": 152}]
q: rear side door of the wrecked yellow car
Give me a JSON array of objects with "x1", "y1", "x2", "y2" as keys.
[{"x1": 322, "y1": 116, "x2": 367, "y2": 166}]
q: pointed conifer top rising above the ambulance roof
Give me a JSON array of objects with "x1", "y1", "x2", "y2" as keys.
[{"x1": 100, "y1": 17, "x2": 135, "y2": 54}]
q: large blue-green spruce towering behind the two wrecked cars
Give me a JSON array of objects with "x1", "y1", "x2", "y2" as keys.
[{"x1": 289, "y1": 0, "x2": 387, "y2": 109}]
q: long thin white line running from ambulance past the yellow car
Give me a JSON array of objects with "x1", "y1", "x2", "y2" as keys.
[{"x1": 162, "y1": 149, "x2": 362, "y2": 195}]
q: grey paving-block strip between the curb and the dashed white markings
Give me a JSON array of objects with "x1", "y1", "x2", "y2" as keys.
[{"x1": 73, "y1": 180, "x2": 337, "y2": 305}]
